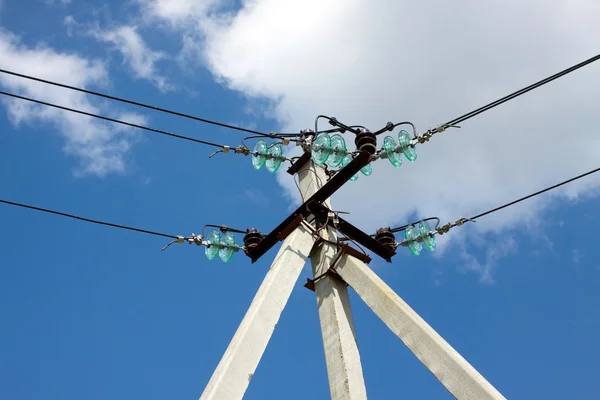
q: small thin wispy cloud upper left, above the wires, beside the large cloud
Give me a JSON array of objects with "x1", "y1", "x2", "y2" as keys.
[{"x1": 86, "y1": 24, "x2": 171, "y2": 90}]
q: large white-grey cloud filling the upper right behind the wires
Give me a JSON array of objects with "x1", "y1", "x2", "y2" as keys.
[{"x1": 137, "y1": 0, "x2": 600, "y2": 276}]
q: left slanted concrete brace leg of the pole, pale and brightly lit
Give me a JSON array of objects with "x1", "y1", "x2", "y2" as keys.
[{"x1": 200, "y1": 225, "x2": 315, "y2": 400}]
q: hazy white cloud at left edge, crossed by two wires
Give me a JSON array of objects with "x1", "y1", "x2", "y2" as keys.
[{"x1": 0, "y1": 30, "x2": 143, "y2": 176}]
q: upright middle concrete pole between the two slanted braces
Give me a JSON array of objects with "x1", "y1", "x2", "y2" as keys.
[{"x1": 299, "y1": 162, "x2": 367, "y2": 400}]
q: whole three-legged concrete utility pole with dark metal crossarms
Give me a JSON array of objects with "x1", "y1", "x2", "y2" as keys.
[{"x1": 200, "y1": 129, "x2": 505, "y2": 400}]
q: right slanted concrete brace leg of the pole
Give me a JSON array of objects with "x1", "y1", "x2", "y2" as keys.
[{"x1": 335, "y1": 255, "x2": 505, "y2": 400}]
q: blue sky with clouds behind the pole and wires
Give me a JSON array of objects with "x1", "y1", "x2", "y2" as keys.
[{"x1": 0, "y1": 0, "x2": 600, "y2": 400}]
